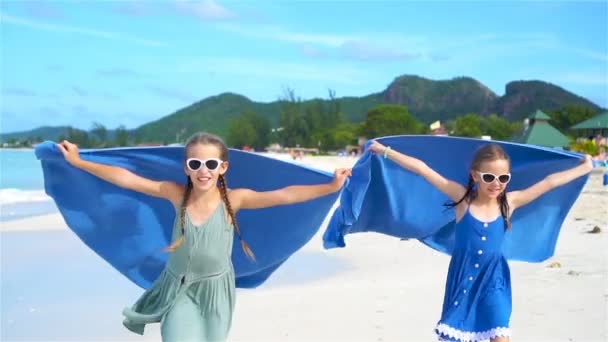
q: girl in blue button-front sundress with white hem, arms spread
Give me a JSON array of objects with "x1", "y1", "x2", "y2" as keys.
[{"x1": 369, "y1": 141, "x2": 593, "y2": 342}]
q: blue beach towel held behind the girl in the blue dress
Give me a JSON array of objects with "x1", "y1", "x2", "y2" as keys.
[{"x1": 323, "y1": 136, "x2": 588, "y2": 262}]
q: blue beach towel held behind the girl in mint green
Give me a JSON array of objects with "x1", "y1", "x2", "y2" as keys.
[{"x1": 35, "y1": 142, "x2": 338, "y2": 288}]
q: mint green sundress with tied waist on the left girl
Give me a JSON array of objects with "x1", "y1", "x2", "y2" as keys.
[{"x1": 123, "y1": 202, "x2": 235, "y2": 342}]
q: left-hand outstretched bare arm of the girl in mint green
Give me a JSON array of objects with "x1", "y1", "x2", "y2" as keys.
[{"x1": 57, "y1": 140, "x2": 184, "y2": 205}]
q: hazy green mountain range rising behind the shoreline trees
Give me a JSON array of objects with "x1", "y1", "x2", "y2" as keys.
[{"x1": 0, "y1": 75, "x2": 601, "y2": 143}]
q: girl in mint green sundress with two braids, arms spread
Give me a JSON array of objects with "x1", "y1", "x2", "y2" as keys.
[{"x1": 57, "y1": 133, "x2": 351, "y2": 341}]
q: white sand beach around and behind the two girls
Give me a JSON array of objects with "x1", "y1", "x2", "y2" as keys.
[{"x1": 1, "y1": 157, "x2": 608, "y2": 342}]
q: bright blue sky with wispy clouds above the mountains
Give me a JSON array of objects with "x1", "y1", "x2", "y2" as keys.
[{"x1": 0, "y1": 0, "x2": 608, "y2": 133}]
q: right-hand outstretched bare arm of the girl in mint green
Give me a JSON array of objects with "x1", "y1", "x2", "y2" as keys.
[{"x1": 230, "y1": 169, "x2": 351, "y2": 210}]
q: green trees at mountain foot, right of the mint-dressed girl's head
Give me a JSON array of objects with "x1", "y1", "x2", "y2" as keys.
[{"x1": 228, "y1": 89, "x2": 596, "y2": 151}]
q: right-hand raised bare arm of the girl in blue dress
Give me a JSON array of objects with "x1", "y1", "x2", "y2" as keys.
[{"x1": 507, "y1": 155, "x2": 593, "y2": 210}]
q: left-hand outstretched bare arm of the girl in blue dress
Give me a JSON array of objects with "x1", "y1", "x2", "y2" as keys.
[{"x1": 369, "y1": 140, "x2": 466, "y2": 202}]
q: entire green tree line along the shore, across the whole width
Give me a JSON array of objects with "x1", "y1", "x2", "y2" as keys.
[{"x1": 2, "y1": 96, "x2": 597, "y2": 151}]
